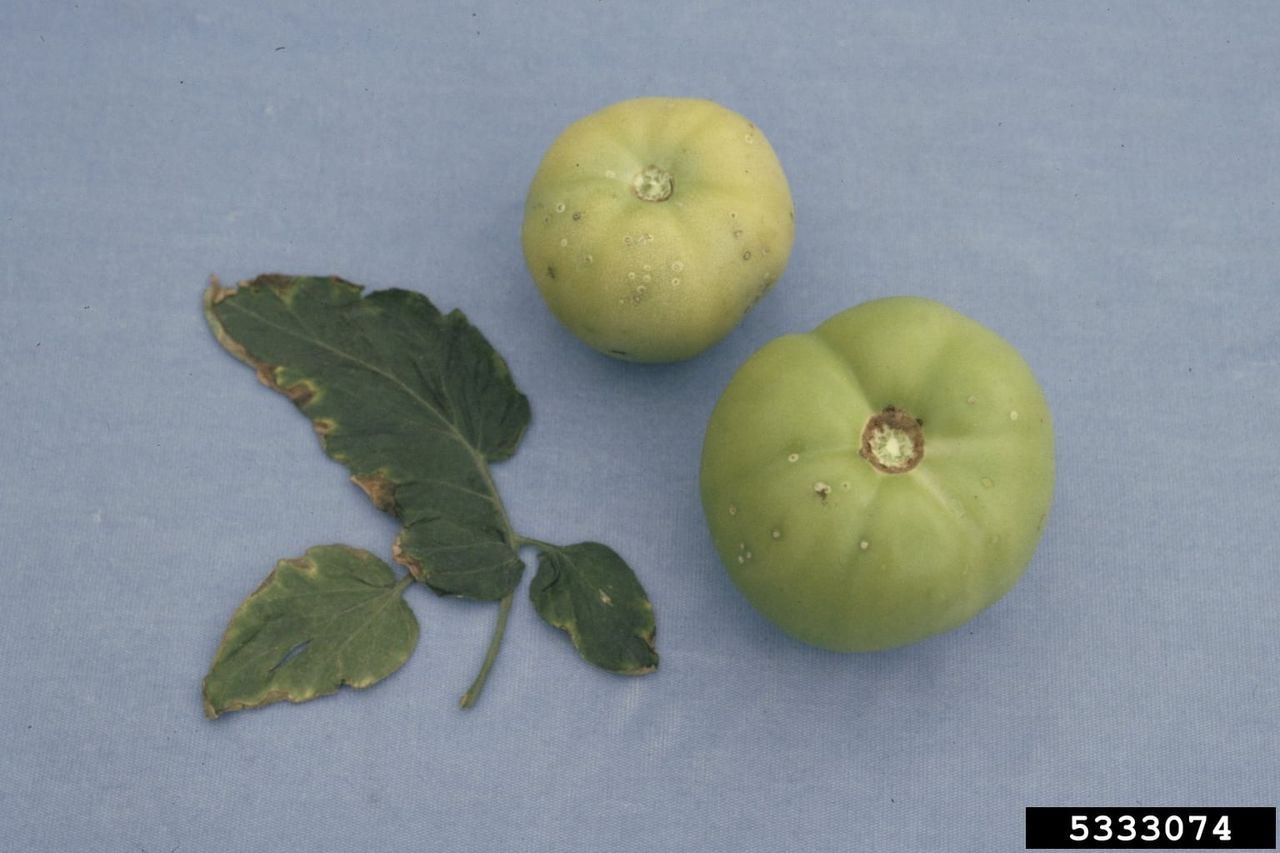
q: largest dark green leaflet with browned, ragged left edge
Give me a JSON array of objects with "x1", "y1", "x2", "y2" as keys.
[{"x1": 205, "y1": 275, "x2": 530, "y2": 599}]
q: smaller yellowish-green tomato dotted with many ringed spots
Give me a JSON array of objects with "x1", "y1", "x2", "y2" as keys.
[{"x1": 522, "y1": 97, "x2": 795, "y2": 361}]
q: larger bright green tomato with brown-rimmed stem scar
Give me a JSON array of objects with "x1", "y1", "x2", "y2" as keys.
[{"x1": 701, "y1": 297, "x2": 1053, "y2": 652}]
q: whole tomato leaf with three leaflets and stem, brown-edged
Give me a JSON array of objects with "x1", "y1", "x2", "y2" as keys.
[{"x1": 205, "y1": 275, "x2": 658, "y2": 717}]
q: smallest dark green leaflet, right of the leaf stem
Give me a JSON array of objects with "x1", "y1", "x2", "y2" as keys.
[{"x1": 529, "y1": 542, "x2": 658, "y2": 675}]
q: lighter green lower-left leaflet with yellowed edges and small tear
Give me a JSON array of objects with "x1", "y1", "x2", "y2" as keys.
[{"x1": 204, "y1": 546, "x2": 419, "y2": 719}]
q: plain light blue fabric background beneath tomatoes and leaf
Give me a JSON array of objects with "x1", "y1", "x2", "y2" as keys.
[{"x1": 0, "y1": 0, "x2": 1280, "y2": 853}]
